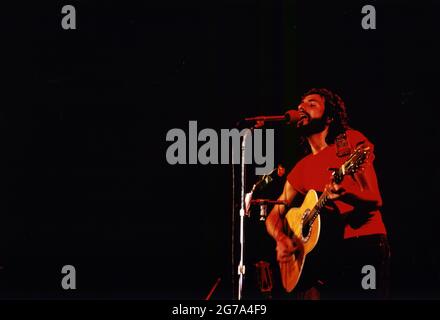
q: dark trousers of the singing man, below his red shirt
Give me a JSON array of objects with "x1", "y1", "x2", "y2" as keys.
[{"x1": 284, "y1": 234, "x2": 390, "y2": 300}]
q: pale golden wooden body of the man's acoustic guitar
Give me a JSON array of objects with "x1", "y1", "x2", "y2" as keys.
[{"x1": 280, "y1": 190, "x2": 321, "y2": 292}]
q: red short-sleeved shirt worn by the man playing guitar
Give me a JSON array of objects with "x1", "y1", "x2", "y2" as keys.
[{"x1": 287, "y1": 130, "x2": 386, "y2": 239}]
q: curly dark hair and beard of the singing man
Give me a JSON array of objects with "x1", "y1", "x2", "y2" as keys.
[{"x1": 301, "y1": 88, "x2": 350, "y2": 154}]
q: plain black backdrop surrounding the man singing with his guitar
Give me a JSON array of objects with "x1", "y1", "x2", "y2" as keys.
[{"x1": 0, "y1": 0, "x2": 440, "y2": 299}]
